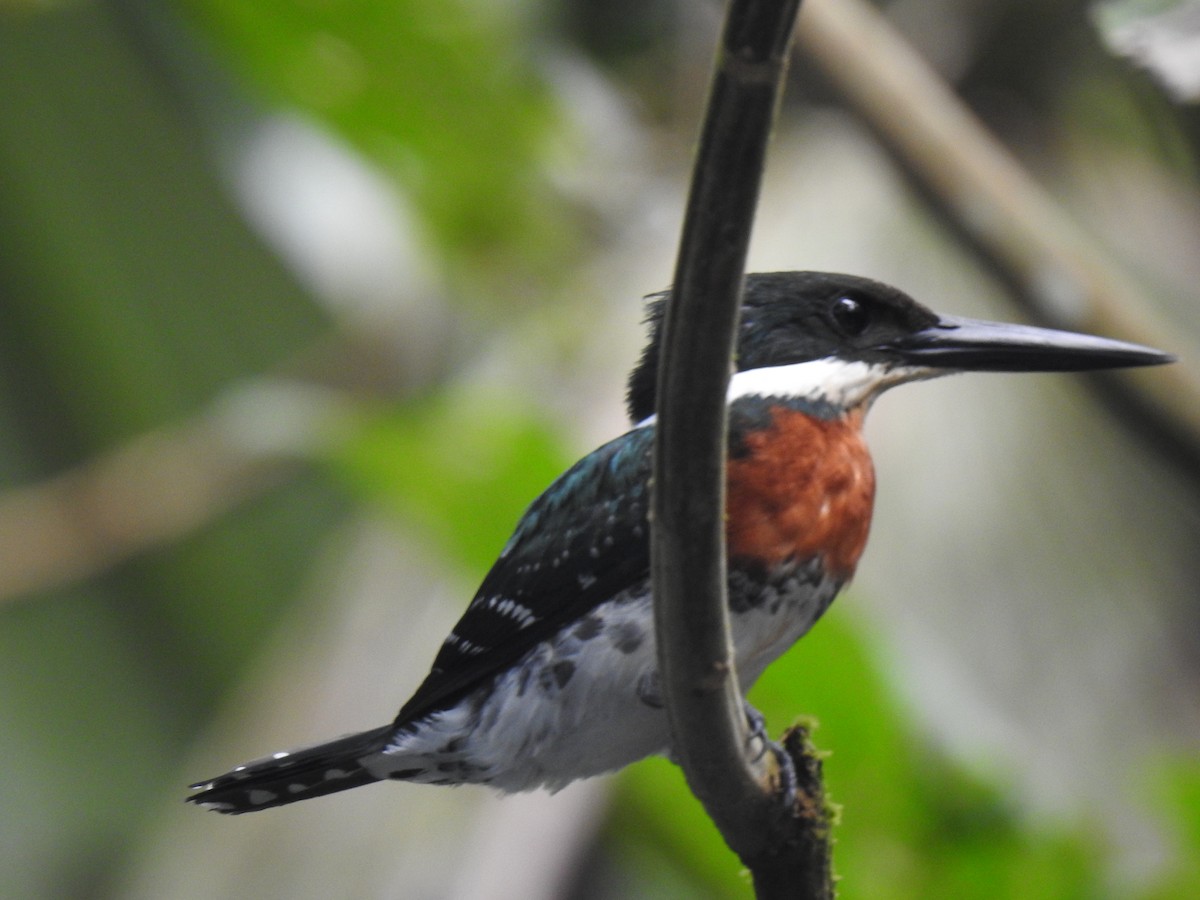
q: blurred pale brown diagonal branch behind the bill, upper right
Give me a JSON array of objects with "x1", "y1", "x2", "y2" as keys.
[{"x1": 797, "y1": 0, "x2": 1200, "y2": 481}]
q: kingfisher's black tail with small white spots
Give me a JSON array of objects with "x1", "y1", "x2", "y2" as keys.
[{"x1": 187, "y1": 725, "x2": 392, "y2": 815}]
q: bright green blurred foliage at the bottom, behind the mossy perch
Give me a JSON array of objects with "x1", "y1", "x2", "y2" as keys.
[{"x1": 608, "y1": 614, "x2": 1123, "y2": 900}]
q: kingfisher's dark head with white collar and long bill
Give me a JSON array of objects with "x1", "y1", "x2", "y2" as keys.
[{"x1": 626, "y1": 272, "x2": 1172, "y2": 422}]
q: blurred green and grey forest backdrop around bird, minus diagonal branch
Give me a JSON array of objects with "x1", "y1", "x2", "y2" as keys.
[{"x1": 0, "y1": 0, "x2": 1200, "y2": 900}]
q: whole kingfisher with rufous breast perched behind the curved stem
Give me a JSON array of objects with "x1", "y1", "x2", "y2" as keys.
[{"x1": 187, "y1": 271, "x2": 1172, "y2": 814}]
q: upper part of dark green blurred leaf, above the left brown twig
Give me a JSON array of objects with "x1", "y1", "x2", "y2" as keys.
[{"x1": 0, "y1": 8, "x2": 324, "y2": 451}]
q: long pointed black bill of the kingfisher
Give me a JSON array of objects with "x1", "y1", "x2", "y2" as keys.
[{"x1": 889, "y1": 316, "x2": 1175, "y2": 372}]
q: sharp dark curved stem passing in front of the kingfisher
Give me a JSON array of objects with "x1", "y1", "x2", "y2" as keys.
[{"x1": 652, "y1": 0, "x2": 828, "y2": 896}]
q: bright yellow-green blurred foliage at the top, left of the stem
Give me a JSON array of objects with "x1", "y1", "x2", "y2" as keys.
[{"x1": 180, "y1": 0, "x2": 570, "y2": 287}]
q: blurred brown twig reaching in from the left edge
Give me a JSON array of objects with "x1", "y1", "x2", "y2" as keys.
[{"x1": 0, "y1": 329, "x2": 444, "y2": 606}]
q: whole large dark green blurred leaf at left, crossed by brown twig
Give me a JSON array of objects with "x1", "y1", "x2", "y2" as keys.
[{"x1": 0, "y1": 4, "x2": 338, "y2": 898}]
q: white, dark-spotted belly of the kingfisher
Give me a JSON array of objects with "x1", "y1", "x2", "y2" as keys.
[{"x1": 365, "y1": 571, "x2": 840, "y2": 791}]
